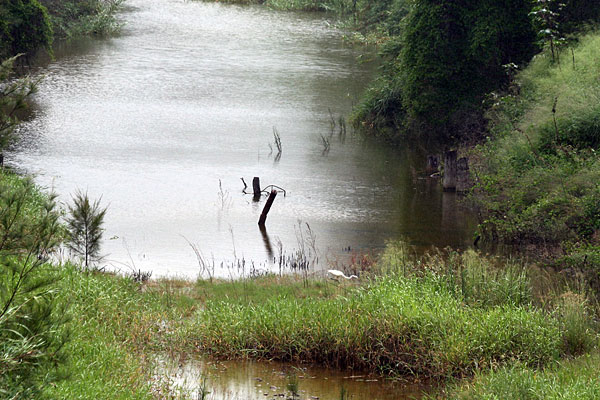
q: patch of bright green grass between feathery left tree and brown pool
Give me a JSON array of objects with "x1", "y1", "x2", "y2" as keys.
[{"x1": 46, "y1": 265, "x2": 162, "y2": 399}]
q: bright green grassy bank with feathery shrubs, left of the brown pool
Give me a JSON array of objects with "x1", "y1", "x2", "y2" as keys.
[{"x1": 0, "y1": 171, "x2": 160, "y2": 399}]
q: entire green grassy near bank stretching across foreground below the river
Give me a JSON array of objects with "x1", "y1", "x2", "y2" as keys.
[{"x1": 0, "y1": 173, "x2": 597, "y2": 399}]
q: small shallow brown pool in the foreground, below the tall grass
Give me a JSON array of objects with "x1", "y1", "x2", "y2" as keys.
[{"x1": 157, "y1": 360, "x2": 431, "y2": 400}]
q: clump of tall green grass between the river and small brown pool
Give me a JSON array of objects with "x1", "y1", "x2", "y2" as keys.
[{"x1": 182, "y1": 246, "x2": 595, "y2": 378}]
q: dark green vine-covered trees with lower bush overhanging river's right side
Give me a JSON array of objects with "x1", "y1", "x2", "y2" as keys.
[{"x1": 353, "y1": 0, "x2": 600, "y2": 145}]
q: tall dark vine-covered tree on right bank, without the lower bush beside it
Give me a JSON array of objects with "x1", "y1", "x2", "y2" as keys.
[{"x1": 399, "y1": 0, "x2": 535, "y2": 142}]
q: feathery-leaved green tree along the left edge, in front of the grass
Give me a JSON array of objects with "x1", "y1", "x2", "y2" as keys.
[{"x1": 0, "y1": 172, "x2": 68, "y2": 399}]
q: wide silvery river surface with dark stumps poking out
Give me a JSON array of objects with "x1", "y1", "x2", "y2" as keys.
[{"x1": 7, "y1": 0, "x2": 471, "y2": 277}]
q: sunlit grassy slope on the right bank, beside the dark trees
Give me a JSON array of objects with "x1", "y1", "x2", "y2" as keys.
[{"x1": 472, "y1": 33, "x2": 600, "y2": 270}]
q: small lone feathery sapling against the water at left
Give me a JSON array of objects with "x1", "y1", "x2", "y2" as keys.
[{"x1": 67, "y1": 191, "x2": 106, "y2": 269}]
